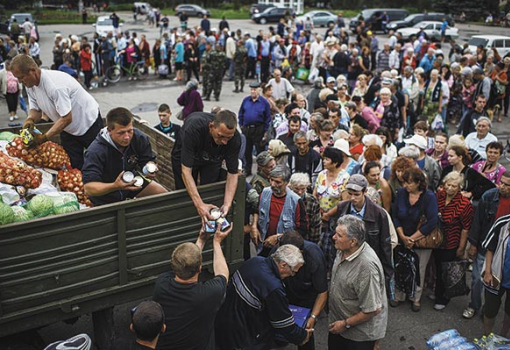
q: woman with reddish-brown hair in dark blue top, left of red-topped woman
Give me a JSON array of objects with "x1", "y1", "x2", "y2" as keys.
[{"x1": 392, "y1": 168, "x2": 438, "y2": 312}]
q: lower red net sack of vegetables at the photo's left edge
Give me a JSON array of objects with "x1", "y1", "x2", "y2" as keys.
[{"x1": 0, "y1": 152, "x2": 42, "y2": 188}]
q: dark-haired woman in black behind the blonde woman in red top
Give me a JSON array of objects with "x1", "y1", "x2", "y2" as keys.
[{"x1": 441, "y1": 146, "x2": 495, "y2": 201}]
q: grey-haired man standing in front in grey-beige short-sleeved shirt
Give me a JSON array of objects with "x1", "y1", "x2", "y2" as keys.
[{"x1": 328, "y1": 215, "x2": 388, "y2": 349}]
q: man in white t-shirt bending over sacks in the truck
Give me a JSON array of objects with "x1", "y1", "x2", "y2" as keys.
[{"x1": 11, "y1": 54, "x2": 103, "y2": 169}]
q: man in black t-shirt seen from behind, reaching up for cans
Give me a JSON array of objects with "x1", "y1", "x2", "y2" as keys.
[{"x1": 153, "y1": 225, "x2": 232, "y2": 350}]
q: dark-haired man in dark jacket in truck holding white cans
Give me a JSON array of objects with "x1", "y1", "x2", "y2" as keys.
[{"x1": 82, "y1": 107, "x2": 167, "y2": 205}]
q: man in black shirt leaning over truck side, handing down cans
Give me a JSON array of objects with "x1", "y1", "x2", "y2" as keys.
[{"x1": 172, "y1": 109, "x2": 241, "y2": 224}]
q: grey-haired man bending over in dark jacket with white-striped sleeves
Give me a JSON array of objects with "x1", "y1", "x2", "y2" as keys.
[{"x1": 215, "y1": 244, "x2": 313, "y2": 350}]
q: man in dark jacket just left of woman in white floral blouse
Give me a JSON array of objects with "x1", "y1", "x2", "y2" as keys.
[{"x1": 289, "y1": 130, "x2": 322, "y2": 184}]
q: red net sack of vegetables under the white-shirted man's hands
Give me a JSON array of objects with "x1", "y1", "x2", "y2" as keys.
[{"x1": 6, "y1": 136, "x2": 71, "y2": 170}]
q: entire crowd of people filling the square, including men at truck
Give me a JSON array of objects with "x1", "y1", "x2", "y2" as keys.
[{"x1": 0, "y1": 7, "x2": 510, "y2": 349}]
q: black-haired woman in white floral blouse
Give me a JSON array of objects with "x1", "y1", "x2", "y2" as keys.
[{"x1": 313, "y1": 147, "x2": 349, "y2": 269}]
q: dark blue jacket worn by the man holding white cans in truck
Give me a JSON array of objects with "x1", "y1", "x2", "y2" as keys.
[{"x1": 82, "y1": 127, "x2": 156, "y2": 205}]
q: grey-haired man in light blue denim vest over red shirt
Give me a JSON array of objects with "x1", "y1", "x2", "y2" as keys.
[{"x1": 250, "y1": 165, "x2": 308, "y2": 256}]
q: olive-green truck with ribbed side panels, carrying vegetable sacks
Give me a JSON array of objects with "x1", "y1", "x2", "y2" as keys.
[{"x1": 0, "y1": 120, "x2": 245, "y2": 350}]
